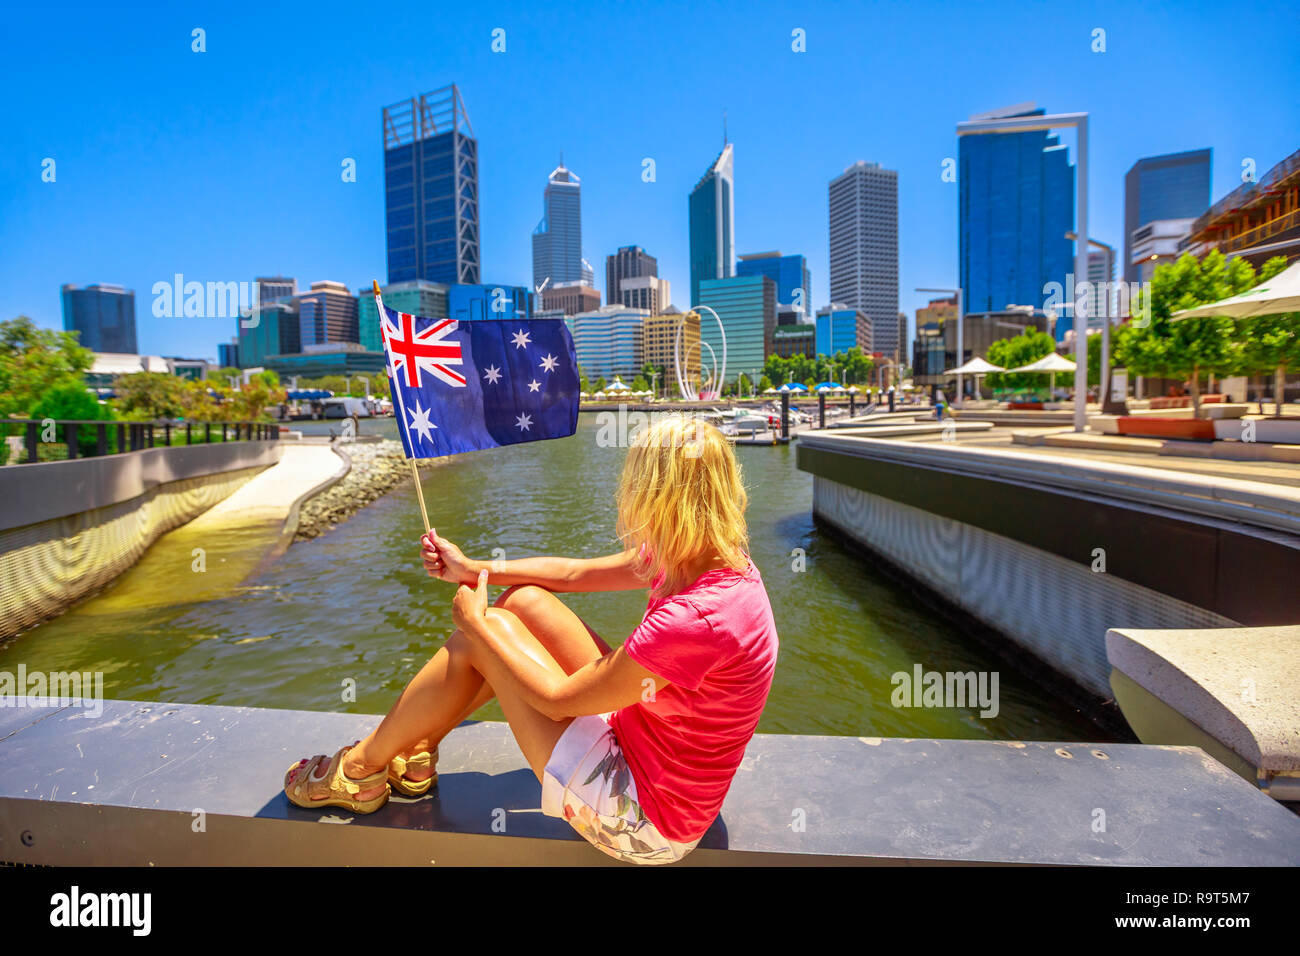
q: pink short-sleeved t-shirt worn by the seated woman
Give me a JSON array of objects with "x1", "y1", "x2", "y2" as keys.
[{"x1": 610, "y1": 562, "x2": 777, "y2": 843}]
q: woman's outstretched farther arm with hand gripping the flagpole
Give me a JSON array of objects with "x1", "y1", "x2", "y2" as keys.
[{"x1": 420, "y1": 531, "x2": 647, "y2": 592}]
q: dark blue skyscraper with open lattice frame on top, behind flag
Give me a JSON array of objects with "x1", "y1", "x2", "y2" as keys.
[{"x1": 384, "y1": 85, "x2": 480, "y2": 285}]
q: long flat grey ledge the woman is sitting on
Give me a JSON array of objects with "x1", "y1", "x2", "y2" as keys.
[{"x1": 0, "y1": 701, "x2": 1300, "y2": 866}]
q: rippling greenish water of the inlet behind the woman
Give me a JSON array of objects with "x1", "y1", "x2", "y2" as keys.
[{"x1": 0, "y1": 415, "x2": 1106, "y2": 740}]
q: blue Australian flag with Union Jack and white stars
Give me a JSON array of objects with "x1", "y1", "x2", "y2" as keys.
[{"x1": 381, "y1": 303, "x2": 579, "y2": 458}]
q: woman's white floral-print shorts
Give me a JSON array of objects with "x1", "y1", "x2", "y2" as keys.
[{"x1": 542, "y1": 714, "x2": 699, "y2": 864}]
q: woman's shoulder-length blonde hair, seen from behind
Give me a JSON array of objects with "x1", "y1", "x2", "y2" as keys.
[{"x1": 618, "y1": 415, "x2": 749, "y2": 597}]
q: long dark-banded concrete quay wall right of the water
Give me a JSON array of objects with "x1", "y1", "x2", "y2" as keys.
[{"x1": 798, "y1": 432, "x2": 1300, "y2": 704}]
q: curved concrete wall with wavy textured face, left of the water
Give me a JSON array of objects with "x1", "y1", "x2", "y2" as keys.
[{"x1": 0, "y1": 441, "x2": 283, "y2": 640}]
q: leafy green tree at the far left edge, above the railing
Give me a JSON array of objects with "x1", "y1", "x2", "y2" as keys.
[{"x1": 0, "y1": 315, "x2": 95, "y2": 418}]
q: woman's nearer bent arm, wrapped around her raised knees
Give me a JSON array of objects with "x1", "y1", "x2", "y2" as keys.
[{"x1": 451, "y1": 575, "x2": 668, "y2": 721}]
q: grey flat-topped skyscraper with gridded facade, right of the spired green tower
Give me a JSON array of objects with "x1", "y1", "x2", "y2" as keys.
[{"x1": 828, "y1": 160, "x2": 898, "y2": 356}]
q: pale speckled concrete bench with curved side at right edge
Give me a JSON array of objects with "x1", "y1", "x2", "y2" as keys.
[{"x1": 1106, "y1": 627, "x2": 1300, "y2": 800}]
